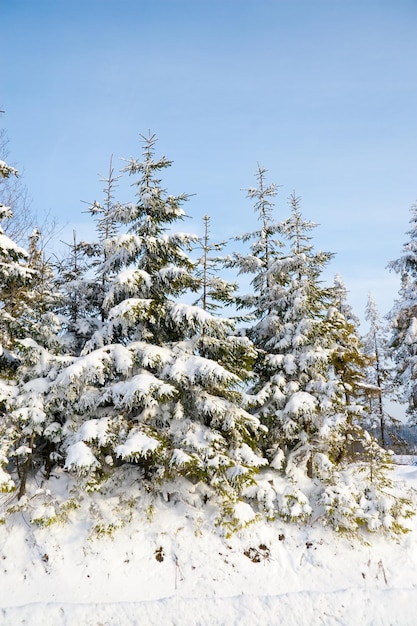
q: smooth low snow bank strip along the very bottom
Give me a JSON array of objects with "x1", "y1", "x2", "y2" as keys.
[{"x1": 0, "y1": 589, "x2": 417, "y2": 626}]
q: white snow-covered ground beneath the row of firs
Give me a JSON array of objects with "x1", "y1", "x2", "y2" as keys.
[{"x1": 0, "y1": 465, "x2": 417, "y2": 626}]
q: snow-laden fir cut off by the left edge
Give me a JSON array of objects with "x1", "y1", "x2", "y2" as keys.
[{"x1": 0, "y1": 193, "x2": 65, "y2": 497}]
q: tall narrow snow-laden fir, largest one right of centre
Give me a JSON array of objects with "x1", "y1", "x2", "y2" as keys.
[{"x1": 254, "y1": 194, "x2": 344, "y2": 476}]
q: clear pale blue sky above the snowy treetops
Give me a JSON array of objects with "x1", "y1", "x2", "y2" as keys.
[{"x1": 0, "y1": 0, "x2": 417, "y2": 326}]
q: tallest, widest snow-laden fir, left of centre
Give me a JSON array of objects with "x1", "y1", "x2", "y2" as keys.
[{"x1": 15, "y1": 135, "x2": 266, "y2": 524}]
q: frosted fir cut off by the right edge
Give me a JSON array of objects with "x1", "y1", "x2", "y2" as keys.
[{"x1": 388, "y1": 203, "x2": 417, "y2": 423}]
